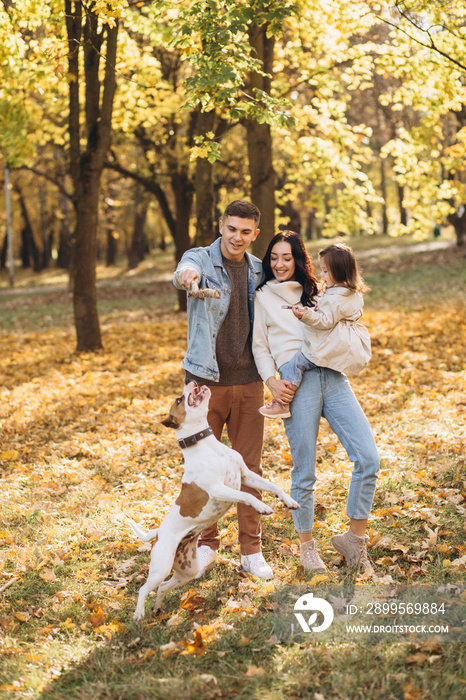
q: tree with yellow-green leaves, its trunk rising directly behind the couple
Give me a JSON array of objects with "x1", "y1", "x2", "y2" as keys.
[{"x1": 167, "y1": 0, "x2": 294, "y2": 254}]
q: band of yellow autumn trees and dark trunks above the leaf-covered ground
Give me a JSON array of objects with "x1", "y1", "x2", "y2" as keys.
[{"x1": 0, "y1": 0, "x2": 466, "y2": 350}]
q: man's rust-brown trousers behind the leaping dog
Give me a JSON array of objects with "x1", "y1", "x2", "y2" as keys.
[{"x1": 199, "y1": 382, "x2": 264, "y2": 554}]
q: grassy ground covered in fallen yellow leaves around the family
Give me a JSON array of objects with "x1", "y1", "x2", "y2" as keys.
[{"x1": 0, "y1": 243, "x2": 466, "y2": 700}]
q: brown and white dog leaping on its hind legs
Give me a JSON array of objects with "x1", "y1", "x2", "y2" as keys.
[{"x1": 129, "y1": 382, "x2": 299, "y2": 620}]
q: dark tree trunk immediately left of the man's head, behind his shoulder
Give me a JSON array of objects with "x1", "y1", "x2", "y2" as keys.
[{"x1": 195, "y1": 110, "x2": 215, "y2": 246}]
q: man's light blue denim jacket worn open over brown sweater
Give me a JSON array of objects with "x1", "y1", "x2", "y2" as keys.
[{"x1": 173, "y1": 238, "x2": 262, "y2": 382}]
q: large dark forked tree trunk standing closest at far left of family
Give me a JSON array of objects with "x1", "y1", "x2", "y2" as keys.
[{"x1": 65, "y1": 0, "x2": 118, "y2": 351}]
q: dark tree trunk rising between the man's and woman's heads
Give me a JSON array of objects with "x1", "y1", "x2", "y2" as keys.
[{"x1": 246, "y1": 25, "x2": 275, "y2": 257}]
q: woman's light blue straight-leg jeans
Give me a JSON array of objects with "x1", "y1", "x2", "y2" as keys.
[{"x1": 283, "y1": 367, "x2": 380, "y2": 533}]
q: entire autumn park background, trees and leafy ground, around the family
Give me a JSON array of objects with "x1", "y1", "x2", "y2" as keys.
[{"x1": 0, "y1": 0, "x2": 466, "y2": 700}]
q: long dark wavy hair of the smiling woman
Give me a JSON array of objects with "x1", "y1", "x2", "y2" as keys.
[{"x1": 258, "y1": 231, "x2": 318, "y2": 306}]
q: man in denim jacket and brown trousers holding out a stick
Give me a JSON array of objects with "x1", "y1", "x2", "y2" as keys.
[{"x1": 174, "y1": 200, "x2": 273, "y2": 579}]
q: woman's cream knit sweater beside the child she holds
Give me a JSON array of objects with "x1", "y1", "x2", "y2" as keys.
[{"x1": 252, "y1": 280, "x2": 305, "y2": 382}]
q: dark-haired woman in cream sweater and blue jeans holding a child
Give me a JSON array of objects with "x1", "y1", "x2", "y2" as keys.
[{"x1": 252, "y1": 231, "x2": 379, "y2": 575}]
